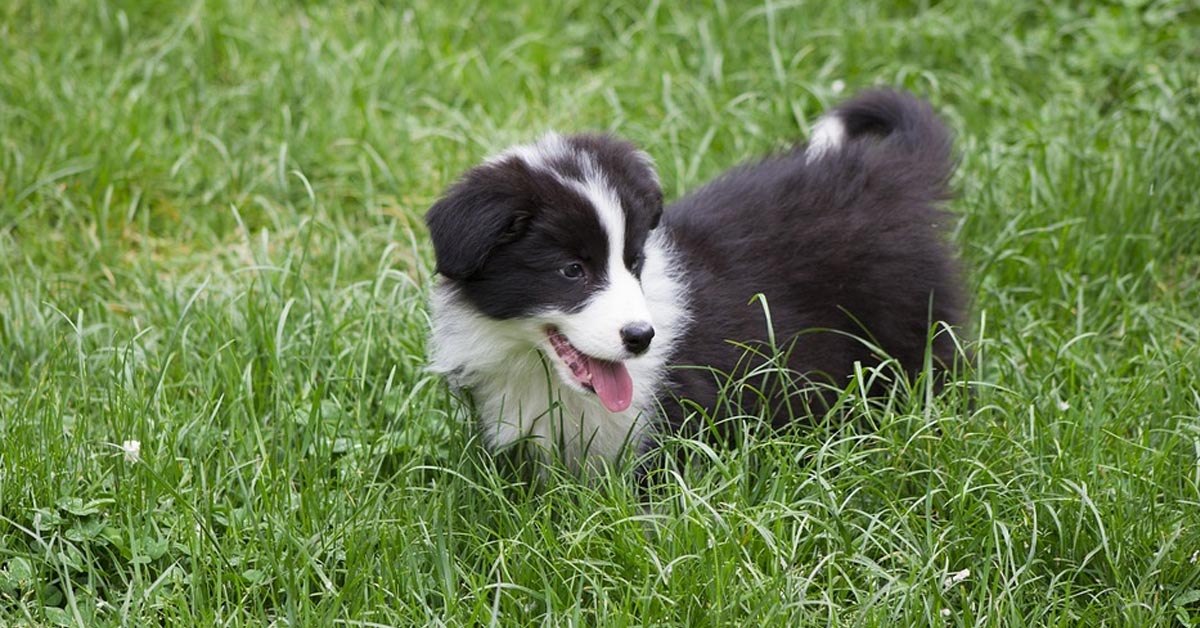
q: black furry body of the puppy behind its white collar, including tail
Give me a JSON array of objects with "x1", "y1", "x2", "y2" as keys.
[{"x1": 662, "y1": 91, "x2": 965, "y2": 427}]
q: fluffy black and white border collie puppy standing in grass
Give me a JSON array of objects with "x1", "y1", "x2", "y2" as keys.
[{"x1": 426, "y1": 90, "x2": 964, "y2": 468}]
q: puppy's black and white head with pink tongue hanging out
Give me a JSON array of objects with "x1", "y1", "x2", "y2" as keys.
[{"x1": 426, "y1": 134, "x2": 662, "y2": 412}]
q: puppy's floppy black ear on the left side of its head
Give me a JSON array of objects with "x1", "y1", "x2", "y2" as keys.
[{"x1": 425, "y1": 165, "x2": 533, "y2": 280}]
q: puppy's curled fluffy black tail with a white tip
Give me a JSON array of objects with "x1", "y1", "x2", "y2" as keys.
[{"x1": 805, "y1": 89, "x2": 954, "y2": 183}]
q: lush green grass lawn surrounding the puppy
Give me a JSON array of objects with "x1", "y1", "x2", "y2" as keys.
[{"x1": 0, "y1": 0, "x2": 1200, "y2": 627}]
